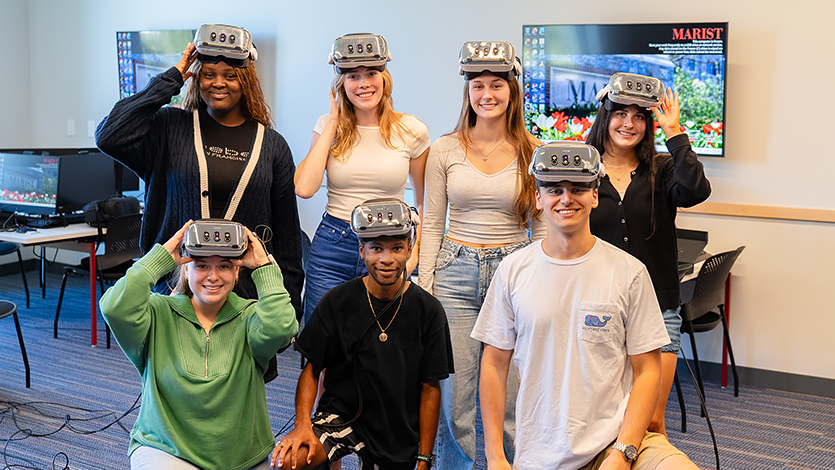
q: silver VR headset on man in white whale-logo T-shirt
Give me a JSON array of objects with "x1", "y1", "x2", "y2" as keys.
[{"x1": 528, "y1": 141, "x2": 606, "y2": 183}]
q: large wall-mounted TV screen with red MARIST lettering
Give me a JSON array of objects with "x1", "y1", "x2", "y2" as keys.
[{"x1": 522, "y1": 23, "x2": 728, "y2": 157}]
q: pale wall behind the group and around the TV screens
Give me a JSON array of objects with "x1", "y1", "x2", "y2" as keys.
[{"x1": 0, "y1": 0, "x2": 835, "y2": 378}]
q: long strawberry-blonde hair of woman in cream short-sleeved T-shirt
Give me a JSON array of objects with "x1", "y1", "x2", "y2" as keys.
[{"x1": 330, "y1": 69, "x2": 418, "y2": 162}]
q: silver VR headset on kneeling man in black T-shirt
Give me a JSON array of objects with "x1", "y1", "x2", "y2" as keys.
[{"x1": 351, "y1": 199, "x2": 420, "y2": 239}]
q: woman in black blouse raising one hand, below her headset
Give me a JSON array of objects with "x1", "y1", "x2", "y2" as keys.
[{"x1": 586, "y1": 83, "x2": 710, "y2": 436}]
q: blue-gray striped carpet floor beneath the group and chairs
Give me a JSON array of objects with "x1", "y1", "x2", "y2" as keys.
[{"x1": 0, "y1": 272, "x2": 835, "y2": 470}]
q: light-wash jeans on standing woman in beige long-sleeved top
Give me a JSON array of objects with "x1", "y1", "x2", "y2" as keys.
[{"x1": 432, "y1": 238, "x2": 530, "y2": 470}]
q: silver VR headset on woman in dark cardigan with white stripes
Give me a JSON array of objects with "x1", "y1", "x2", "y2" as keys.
[{"x1": 194, "y1": 24, "x2": 258, "y2": 68}]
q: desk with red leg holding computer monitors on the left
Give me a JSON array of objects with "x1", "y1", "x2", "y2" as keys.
[{"x1": 0, "y1": 224, "x2": 99, "y2": 346}]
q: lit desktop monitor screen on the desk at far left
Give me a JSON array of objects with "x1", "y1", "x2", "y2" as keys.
[{"x1": 0, "y1": 153, "x2": 59, "y2": 214}]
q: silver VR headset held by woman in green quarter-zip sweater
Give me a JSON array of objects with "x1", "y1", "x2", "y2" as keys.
[{"x1": 183, "y1": 219, "x2": 247, "y2": 258}]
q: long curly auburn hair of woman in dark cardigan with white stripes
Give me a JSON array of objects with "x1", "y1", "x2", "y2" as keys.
[{"x1": 183, "y1": 61, "x2": 273, "y2": 128}]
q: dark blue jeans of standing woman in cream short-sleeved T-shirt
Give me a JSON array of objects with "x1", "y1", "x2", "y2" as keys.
[{"x1": 304, "y1": 213, "x2": 368, "y2": 323}]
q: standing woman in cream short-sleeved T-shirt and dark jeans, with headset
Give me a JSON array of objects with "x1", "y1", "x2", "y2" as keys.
[{"x1": 294, "y1": 34, "x2": 429, "y2": 320}]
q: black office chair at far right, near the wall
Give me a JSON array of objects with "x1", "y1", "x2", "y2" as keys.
[{"x1": 681, "y1": 246, "x2": 745, "y2": 416}]
